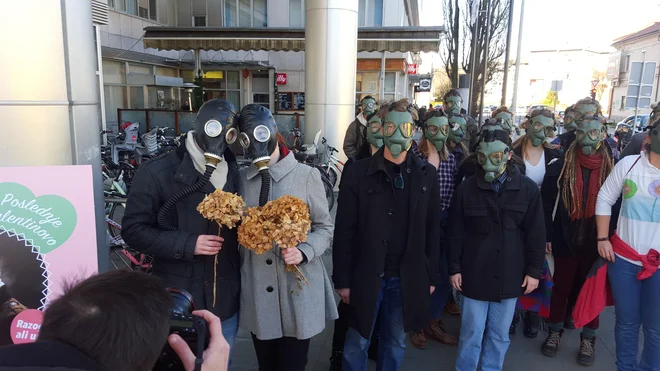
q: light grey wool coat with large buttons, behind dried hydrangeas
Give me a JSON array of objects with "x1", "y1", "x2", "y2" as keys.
[{"x1": 239, "y1": 153, "x2": 338, "y2": 340}]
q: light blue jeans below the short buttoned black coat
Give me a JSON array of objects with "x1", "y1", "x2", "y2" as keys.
[{"x1": 456, "y1": 296, "x2": 518, "y2": 371}]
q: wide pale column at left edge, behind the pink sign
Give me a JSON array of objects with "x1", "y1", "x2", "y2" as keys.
[{"x1": 0, "y1": 0, "x2": 109, "y2": 271}]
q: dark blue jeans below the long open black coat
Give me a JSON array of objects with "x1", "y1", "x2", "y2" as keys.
[{"x1": 342, "y1": 278, "x2": 406, "y2": 371}]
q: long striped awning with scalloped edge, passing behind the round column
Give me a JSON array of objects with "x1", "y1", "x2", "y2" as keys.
[{"x1": 144, "y1": 27, "x2": 445, "y2": 53}]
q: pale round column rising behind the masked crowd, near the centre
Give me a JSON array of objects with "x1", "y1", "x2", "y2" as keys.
[{"x1": 305, "y1": 0, "x2": 358, "y2": 158}]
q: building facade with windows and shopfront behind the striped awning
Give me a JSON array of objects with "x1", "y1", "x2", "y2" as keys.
[{"x1": 98, "y1": 0, "x2": 419, "y2": 132}]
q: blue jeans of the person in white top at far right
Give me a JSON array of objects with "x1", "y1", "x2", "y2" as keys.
[{"x1": 607, "y1": 256, "x2": 660, "y2": 371}]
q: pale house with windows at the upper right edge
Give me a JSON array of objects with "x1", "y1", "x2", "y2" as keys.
[{"x1": 607, "y1": 22, "x2": 660, "y2": 120}]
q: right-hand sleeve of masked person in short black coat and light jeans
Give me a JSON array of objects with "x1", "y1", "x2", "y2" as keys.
[{"x1": 522, "y1": 187, "x2": 546, "y2": 280}]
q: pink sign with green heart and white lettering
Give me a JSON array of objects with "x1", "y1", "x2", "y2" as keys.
[{"x1": 0, "y1": 166, "x2": 98, "y2": 346}]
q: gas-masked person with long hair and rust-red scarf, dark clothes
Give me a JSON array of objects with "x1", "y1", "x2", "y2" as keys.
[{"x1": 541, "y1": 114, "x2": 614, "y2": 366}]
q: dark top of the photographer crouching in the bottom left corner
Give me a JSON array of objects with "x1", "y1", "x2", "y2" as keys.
[{"x1": 0, "y1": 340, "x2": 102, "y2": 371}]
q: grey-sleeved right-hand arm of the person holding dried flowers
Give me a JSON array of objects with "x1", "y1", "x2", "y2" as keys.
[{"x1": 298, "y1": 170, "x2": 334, "y2": 262}]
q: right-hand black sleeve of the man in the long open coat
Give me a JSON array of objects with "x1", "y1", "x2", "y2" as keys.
[{"x1": 426, "y1": 173, "x2": 445, "y2": 286}]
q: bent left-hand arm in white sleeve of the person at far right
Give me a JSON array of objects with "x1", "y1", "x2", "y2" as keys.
[{"x1": 596, "y1": 159, "x2": 636, "y2": 261}]
